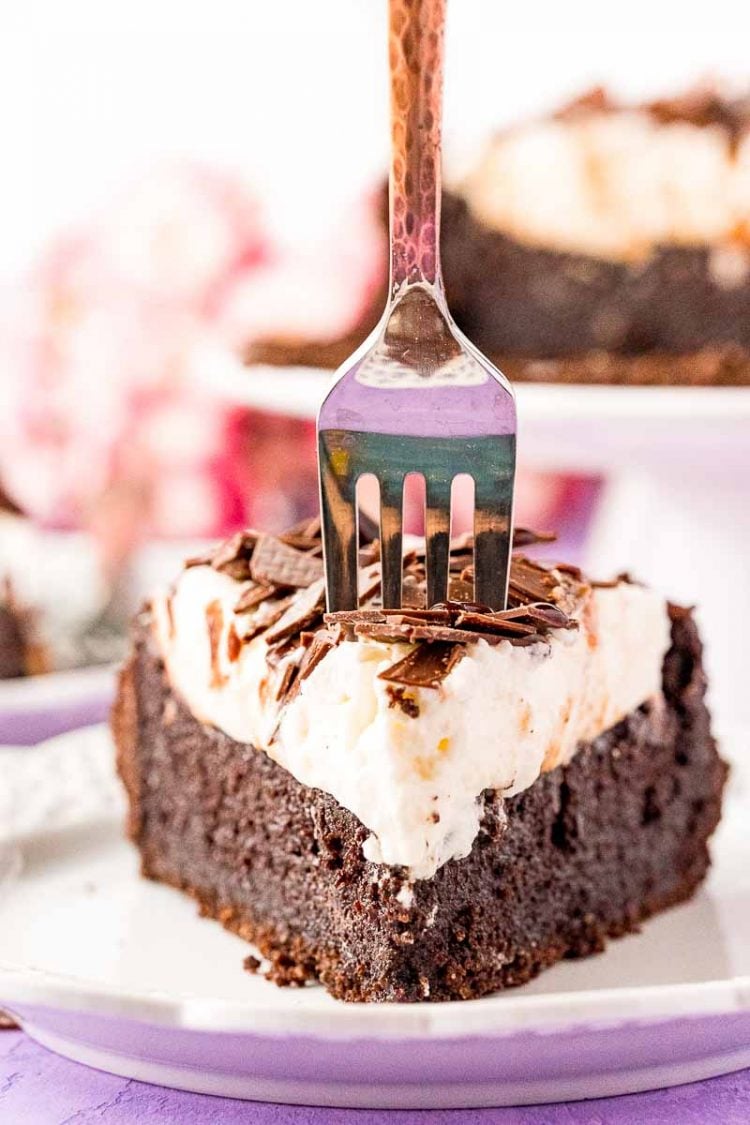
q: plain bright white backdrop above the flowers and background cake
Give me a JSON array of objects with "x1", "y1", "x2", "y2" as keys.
[{"x1": 0, "y1": 0, "x2": 750, "y2": 280}]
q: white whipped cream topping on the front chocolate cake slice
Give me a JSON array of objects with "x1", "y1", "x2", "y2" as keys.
[{"x1": 153, "y1": 566, "x2": 669, "y2": 880}]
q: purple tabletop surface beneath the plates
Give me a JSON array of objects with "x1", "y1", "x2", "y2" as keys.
[{"x1": 0, "y1": 694, "x2": 750, "y2": 1125}]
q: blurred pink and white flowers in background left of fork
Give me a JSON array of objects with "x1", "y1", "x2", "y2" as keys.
[{"x1": 0, "y1": 164, "x2": 382, "y2": 544}]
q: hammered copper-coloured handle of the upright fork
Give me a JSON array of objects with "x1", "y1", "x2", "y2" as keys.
[{"x1": 389, "y1": 0, "x2": 445, "y2": 297}]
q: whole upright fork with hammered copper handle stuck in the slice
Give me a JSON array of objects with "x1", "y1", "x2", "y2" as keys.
[{"x1": 317, "y1": 0, "x2": 516, "y2": 612}]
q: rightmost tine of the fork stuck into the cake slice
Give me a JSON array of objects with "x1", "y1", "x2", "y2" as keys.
[{"x1": 475, "y1": 476, "x2": 513, "y2": 610}]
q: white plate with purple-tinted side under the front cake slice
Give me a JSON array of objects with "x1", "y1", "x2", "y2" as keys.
[{"x1": 0, "y1": 728, "x2": 750, "y2": 1107}]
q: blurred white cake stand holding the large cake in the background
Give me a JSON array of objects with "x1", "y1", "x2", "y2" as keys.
[{"x1": 193, "y1": 351, "x2": 750, "y2": 722}]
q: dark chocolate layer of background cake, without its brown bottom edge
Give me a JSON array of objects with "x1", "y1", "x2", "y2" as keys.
[{"x1": 442, "y1": 195, "x2": 750, "y2": 359}]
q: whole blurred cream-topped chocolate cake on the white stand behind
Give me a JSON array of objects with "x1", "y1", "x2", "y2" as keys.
[{"x1": 247, "y1": 89, "x2": 750, "y2": 385}]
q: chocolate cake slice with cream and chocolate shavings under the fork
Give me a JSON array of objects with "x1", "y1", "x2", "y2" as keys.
[{"x1": 114, "y1": 524, "x2": 725, "y2": 1000}]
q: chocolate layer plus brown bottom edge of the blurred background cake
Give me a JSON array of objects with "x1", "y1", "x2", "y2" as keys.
[{"x1": 245, "y1": 192, "x2": 750, "y2": 386}]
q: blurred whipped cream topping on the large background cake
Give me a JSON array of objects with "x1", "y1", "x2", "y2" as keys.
[{"x1": 463, "y1": 110, "x2": 750, "y2": 260}]
